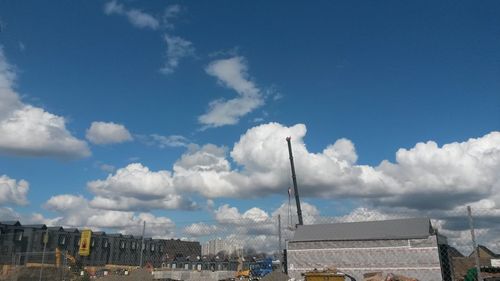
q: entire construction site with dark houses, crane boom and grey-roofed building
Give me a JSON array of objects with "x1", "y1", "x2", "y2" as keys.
[{"x1": 0, "y1": 138, "x2": 500, "y2": 281}]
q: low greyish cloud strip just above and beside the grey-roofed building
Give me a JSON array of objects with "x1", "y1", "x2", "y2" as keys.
[{"x1": 183, "y1": 202, "x2": 500, "y2": 255}]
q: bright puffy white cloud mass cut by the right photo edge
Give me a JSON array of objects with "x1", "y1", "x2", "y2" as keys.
[{"x1": 377, "y1": 132, "x2": 500, "y2": 208}]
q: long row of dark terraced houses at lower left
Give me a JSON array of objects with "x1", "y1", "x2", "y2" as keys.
[{"x1": 0, "y1": 221, "x2": 201, "y2": 267}]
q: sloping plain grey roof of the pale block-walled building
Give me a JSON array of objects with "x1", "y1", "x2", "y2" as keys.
[{"x1": 291, "y1": 218, "x2": 432, "y2": 242}]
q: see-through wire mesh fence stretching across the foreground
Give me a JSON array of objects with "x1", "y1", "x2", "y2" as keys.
[{"x1": 0, "y1": 207, "x2": 500, "y2": 281}]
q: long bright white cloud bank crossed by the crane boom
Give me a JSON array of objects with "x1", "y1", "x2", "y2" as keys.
[{"x1": 89, "y1": 123, "x2": 500, "y2": 209}]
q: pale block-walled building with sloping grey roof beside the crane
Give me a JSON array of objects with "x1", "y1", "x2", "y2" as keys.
[{"x1": 287, "y1": 218, "x2": 452, "y2": 281}]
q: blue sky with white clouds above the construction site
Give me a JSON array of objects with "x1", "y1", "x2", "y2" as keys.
[{"x1": 0, "y1": 1, "x2": 500, "y2": 236}]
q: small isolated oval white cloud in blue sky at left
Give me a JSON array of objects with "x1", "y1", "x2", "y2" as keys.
[{"x1": 86, "y1": 122, "x2": 132, "y2": 144}]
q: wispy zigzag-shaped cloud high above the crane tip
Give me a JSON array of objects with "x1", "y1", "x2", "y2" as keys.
[{"x1": 198, "y1": 57, "x2": 264, "y2": 128}]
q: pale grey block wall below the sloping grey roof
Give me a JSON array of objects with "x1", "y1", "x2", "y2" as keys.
[{"x1": 287, "y1": 236, "x2": 443, "y2": 281}]
